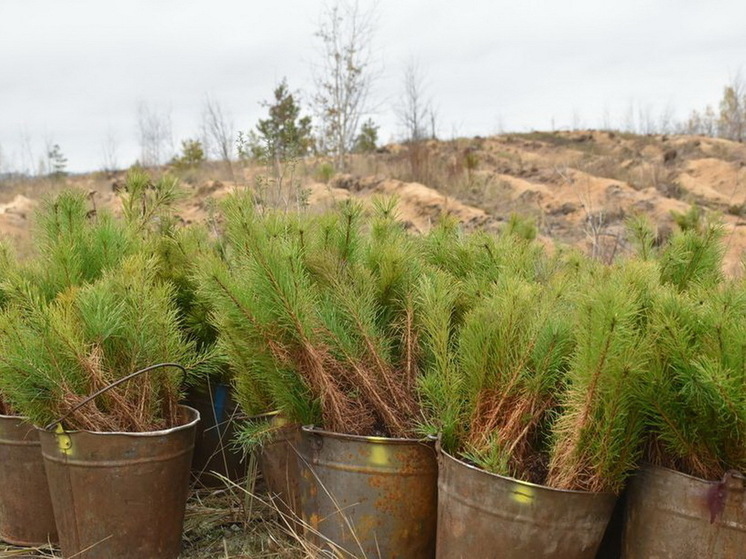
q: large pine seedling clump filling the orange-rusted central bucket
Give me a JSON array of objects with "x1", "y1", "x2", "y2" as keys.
[{"x1": 201, "y1": 194, "x2": 416, "y2": 436}]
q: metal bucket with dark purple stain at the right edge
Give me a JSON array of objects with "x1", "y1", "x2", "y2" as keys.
[{"x1": 622, "y1": 466, "x2": 746, "y2": 559}]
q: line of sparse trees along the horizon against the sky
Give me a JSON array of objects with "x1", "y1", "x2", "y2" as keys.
[{"x1": 0, "y1": 0, "x2": 746, "y2": 179}]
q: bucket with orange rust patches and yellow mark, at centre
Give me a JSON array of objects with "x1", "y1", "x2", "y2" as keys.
[{"x1": 301, "y1": 426, "x2": 438, "y2": 559}]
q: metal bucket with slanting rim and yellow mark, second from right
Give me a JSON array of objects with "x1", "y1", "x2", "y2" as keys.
[{"x1": 437, "y1": 451, "x2": 616, "y2": 559}]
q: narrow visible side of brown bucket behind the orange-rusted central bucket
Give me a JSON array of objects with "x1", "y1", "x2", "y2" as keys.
[{"x1": 259, "y1": 412, "x2": 302, "y2": 531}]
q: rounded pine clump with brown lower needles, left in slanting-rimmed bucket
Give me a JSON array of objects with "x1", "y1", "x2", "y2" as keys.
[{"x1": 458, "y1": 278, "x2": 572, "y2": 483}]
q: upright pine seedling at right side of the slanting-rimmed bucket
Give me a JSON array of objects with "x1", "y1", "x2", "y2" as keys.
[{"x1": 547, "y1": 262, "x2": 657, "y2": 492}]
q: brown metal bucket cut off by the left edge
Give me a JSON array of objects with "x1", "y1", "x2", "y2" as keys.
[{"x1": 0, "y1": 415, "x2": 57, "y2": 546}]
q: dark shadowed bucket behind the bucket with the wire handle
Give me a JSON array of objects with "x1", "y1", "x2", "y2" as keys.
[{"x1": 185, "y1": 380, "x2": 248, "y2": 487}]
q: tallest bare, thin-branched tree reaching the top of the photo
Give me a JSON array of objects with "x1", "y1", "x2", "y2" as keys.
[{"x1": 313, "y1": 1, "x2": 375, "y2": 169}]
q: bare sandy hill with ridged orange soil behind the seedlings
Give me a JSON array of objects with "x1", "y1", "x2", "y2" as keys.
[{"x1": 0, "y1": 130, "x2": 746, "y2": 274}]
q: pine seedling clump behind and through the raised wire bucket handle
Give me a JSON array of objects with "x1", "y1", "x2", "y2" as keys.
[{"x1": 0, "y1": 255, "x2": 209, "y2": 431}]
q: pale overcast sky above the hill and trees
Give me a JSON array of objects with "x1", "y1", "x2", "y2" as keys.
[{"x1": 0, "y1": 0, "x2": 746, "y2": 171}]
